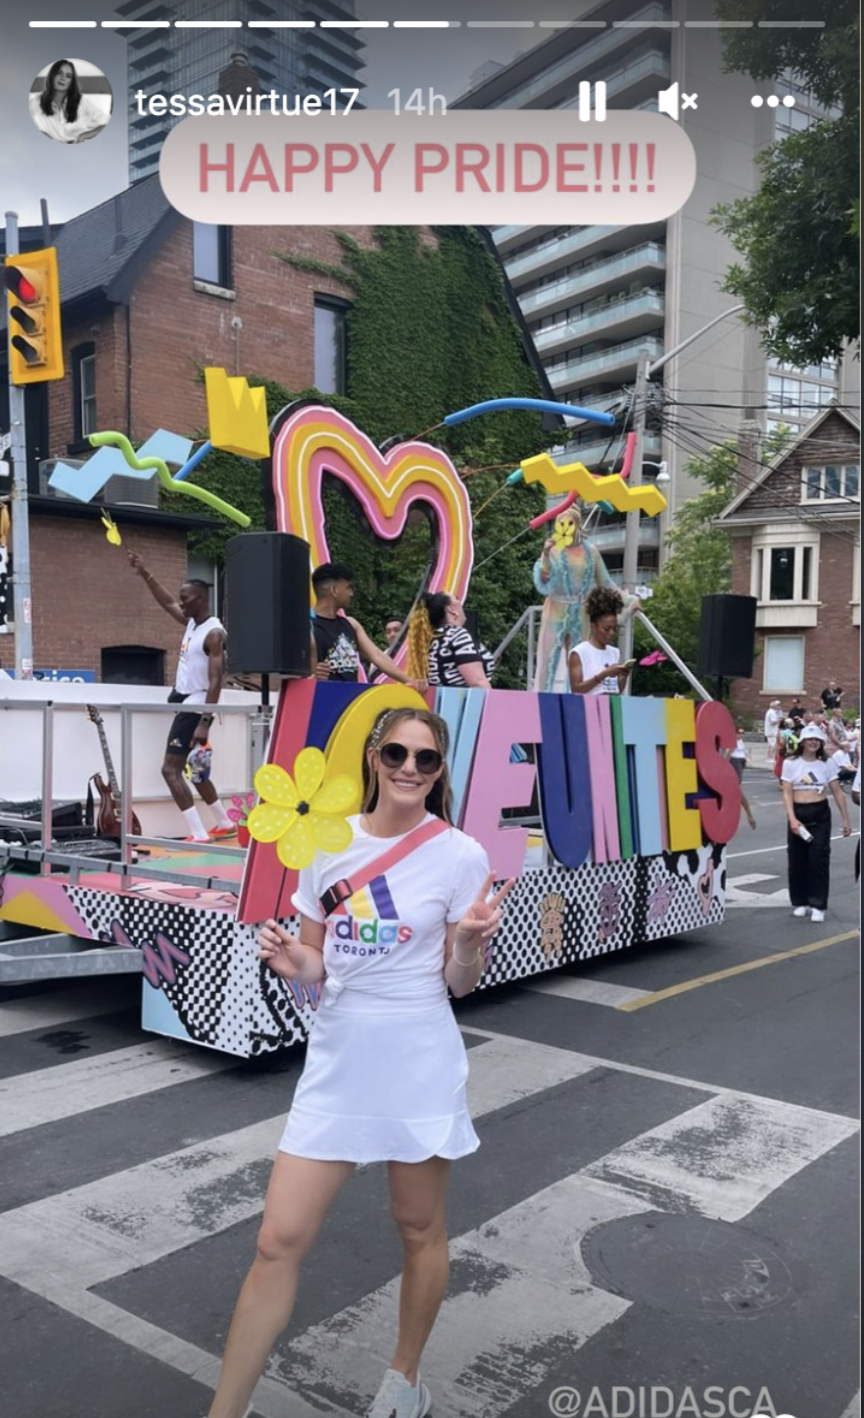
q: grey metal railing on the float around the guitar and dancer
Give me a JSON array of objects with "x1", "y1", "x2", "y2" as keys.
[{"x1": 0, "y1": 699, "x2": 274, "y2": 891}]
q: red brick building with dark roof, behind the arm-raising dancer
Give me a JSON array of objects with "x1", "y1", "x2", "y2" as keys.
[{"x1": 0, "y1": 177, "x2": 372, "y2": 683}]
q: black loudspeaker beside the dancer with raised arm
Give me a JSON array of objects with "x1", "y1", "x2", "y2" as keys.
[{"x1": 224, "y1": 532, "x2": 312, "y2": 679}]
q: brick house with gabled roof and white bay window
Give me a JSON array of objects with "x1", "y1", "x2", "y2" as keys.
[{"x1": 719, "y1": 406, "x2": 861, "y2": 719}]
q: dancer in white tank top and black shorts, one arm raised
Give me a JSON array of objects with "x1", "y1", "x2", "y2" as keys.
[{"x1": 129, "y1": 552, "x2": 237, "y2": 842}]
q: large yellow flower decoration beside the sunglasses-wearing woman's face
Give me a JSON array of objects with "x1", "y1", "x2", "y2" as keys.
[{"x1": 248, "y1": 749, "x2": 358, "y2": 871}]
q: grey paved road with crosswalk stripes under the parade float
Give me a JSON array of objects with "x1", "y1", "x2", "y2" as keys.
[{"x1": 0, "y1": 771, "x2": 860, "y2": 1418}]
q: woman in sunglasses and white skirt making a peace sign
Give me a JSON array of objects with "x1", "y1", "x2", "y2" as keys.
[{"x1": 210, "y1": 709, "x2": 512, "y2": 1418}]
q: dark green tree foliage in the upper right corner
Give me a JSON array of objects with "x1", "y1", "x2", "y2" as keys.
[{"x1": 714, "y1": 0, "x2": 861, "y2": 366}]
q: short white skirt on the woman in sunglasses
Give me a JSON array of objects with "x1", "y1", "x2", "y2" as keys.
[{"x1": 279, "y1": 987, "x2": 480, "y2": 1163}]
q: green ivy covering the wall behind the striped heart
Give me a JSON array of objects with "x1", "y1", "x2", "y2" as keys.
[{"x1": 175, "y1": 227, "x2": 552, "y2": 686}]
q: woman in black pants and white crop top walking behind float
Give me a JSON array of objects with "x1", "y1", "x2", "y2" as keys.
[{"x1": 780, "y1": 725, "x2": 853, "y2": 922}]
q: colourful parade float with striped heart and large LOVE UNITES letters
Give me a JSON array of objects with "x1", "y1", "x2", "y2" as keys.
[{"x1": 0, "y1": 370, "x2": 741, "y2": 1058}]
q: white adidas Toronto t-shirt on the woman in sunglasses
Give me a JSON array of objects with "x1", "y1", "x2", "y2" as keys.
[{"x1": 292, "y1": 814, "x2": 489, "y2": 1000}]
